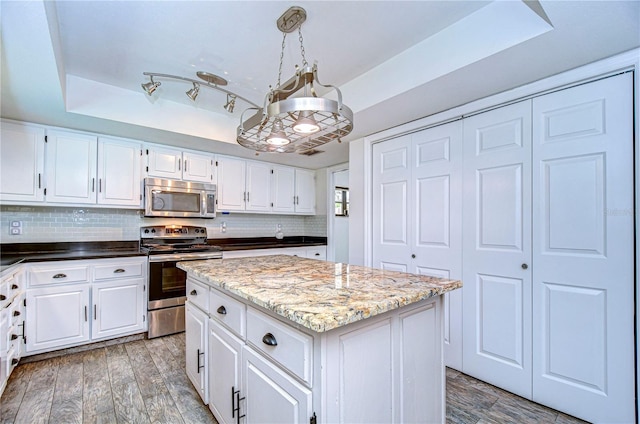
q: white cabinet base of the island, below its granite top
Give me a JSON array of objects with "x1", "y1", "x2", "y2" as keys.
[{"x1": 186, "y1": 276, "x2": 444, "y2": 424}]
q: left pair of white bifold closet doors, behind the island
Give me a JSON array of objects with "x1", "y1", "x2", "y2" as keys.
[{"x1": 373, "y1": 121, "x2": 462, "y2": 370}]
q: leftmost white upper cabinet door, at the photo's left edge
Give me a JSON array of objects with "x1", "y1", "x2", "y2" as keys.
[{"x1": 0, "y1": 122, "x2": 45, "y2": 202}]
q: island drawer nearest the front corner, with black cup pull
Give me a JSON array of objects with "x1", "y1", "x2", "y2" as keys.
[{"x1": 247, "y1": 308, "x2": 313, "y2": 385}]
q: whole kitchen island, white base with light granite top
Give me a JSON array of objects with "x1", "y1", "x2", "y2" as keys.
[{"x1": 178, "y1": 256, "x2": 462, "y2": 423}]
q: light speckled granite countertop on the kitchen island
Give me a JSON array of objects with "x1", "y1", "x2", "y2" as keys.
[{"x1": 178, "y1": 255, "x2": 462, "y2": 332}]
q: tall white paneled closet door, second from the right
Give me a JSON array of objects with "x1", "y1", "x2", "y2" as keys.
[{"x1": 462, "y1": 101, "x2": 532, "y2": 398}]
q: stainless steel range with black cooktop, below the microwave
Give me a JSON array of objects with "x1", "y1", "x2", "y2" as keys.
[{"x1": 140, "y1": 225, "x2": 222, "y2": 339}]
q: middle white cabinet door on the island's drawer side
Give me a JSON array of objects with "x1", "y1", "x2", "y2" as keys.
[{"x1": 208, "y1": 320, "x2": 244, "y2": 424}]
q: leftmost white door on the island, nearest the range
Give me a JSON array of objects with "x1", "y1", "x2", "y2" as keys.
[{"x1": 185, "y1": 302, "x2": 209, "y2": 404}]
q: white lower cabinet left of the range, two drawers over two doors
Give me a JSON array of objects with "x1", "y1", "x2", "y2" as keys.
[{"x1": 25, "y1": 257, "x2": 147, "y2": 355}]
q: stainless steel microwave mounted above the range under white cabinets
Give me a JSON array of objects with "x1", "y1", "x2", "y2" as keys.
[{"x1": 144, "y1": 178, "x2": 216, "y2": 218}]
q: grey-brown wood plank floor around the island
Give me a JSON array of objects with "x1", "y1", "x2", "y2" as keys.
[{"x1": 0, "y1": 333, "x2": 582, "y2": 424}]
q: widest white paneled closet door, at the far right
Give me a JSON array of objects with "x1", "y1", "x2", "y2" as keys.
[{"x1": 533, "y1": 73, "x2": 635, "y2": 423}]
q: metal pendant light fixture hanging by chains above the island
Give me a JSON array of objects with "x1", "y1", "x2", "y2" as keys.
[{"x1": 237, "y1": 6, "x2": 353, "y2": 153}]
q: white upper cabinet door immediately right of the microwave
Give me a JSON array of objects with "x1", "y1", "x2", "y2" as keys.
[{"x1": 217, "y1": 157, "x2": 247, "y2": 211}]
